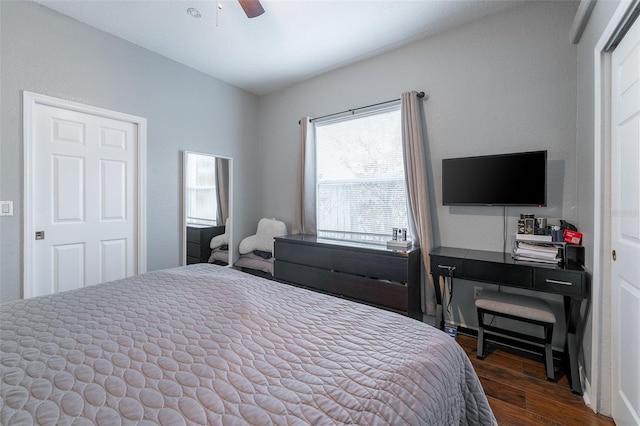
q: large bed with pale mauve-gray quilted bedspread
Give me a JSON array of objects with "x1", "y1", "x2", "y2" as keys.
[{"x1": 0, "y1": 263, "x2": 496, "y2": 425}]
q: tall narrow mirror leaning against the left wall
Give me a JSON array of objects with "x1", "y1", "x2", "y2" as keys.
[{"x1": 182, "y1": 151, "x2": 233, "y2": 266}]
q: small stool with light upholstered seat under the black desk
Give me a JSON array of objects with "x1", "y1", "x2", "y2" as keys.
[{"x1": 475, "y1": 290, "x2": 556, "y2": 380}]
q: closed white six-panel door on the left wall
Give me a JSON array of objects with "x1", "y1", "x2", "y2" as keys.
[{"x1": 24, "y1": 94, "x2": 144, "y2": 297}]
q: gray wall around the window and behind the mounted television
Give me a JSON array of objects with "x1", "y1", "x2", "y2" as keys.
[{"x1": 260, "y1": 1, "x2": 580, "y2": 345}]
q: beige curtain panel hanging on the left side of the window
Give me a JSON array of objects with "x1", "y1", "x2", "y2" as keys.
[{"x1": 292, "y1": 117, "x2": 317, "y2": 235}]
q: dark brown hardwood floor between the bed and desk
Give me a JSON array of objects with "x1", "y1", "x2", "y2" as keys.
[{"x1": 456, "y1": 334, "x2": 614, "y2": 426}]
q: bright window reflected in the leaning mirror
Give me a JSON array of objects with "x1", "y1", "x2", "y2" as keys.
[{"x1": 187, "y1": 153, "x2": 217, "y2": 226}]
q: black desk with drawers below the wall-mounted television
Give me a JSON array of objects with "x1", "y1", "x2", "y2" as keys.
[{"x1": 429, "y1": 247, "x2": 589, "y2": 395}]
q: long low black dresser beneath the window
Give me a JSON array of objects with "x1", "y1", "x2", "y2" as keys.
[{"x1": 274, "y1": 234, "x2": 422, "y2": 320}]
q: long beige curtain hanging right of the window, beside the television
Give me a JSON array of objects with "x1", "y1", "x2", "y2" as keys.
[{"x1": 400, "y1": 92, "x2": 436, "y2": 315}]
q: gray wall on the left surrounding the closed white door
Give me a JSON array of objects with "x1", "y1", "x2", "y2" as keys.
[{"x1": 0, "y1": 1, "x2": 261, "y2": 302}]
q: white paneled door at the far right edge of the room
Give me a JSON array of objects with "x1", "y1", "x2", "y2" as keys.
[{"x1": 611, "y1": 12, "x2": 640, "y2": 425}]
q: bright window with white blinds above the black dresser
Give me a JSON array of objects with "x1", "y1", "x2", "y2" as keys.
[{"x1": 315, "y1": 105, "x2": 408, "y2": 243}]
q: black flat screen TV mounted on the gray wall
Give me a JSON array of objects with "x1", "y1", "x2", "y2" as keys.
[{"x1": 442, "y1": 151, "x2": 547, "y2": 206}]
